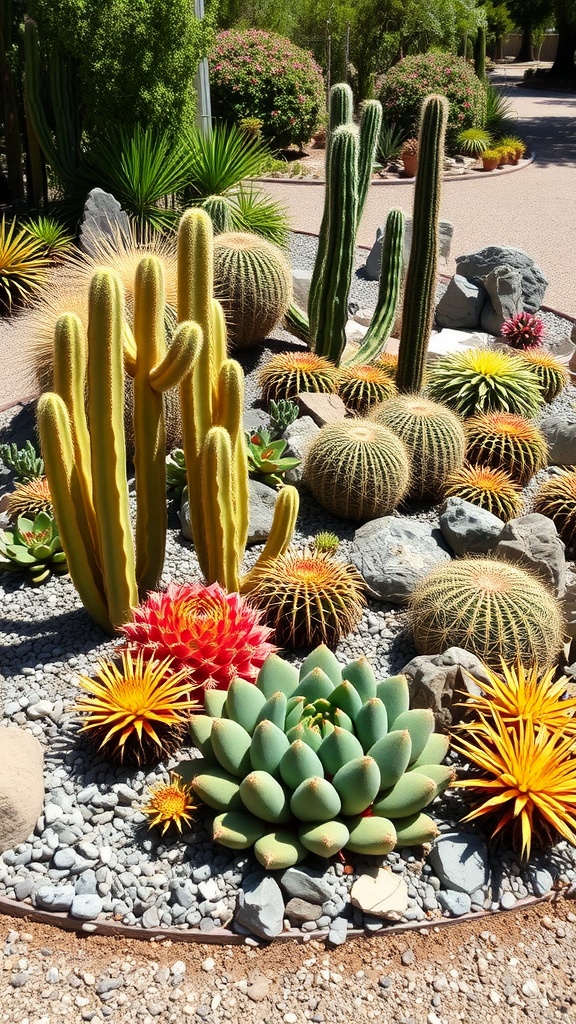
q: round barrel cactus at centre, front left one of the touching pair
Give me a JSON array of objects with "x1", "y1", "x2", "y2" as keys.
[{"x1": 304, "y1": 420, "x2": 410, "y2": 520}]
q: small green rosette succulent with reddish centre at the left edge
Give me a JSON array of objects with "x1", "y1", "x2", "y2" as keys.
[{"x1": 0, "y1": 512, "x2": 68, "y2": 584}]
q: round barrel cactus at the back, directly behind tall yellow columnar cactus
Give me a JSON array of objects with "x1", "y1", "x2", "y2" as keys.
[{"x1": 214, "y1": 231, "x2": 292, "y2": 348}]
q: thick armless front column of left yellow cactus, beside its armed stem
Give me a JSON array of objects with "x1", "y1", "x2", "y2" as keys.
[{"x1": 88, "y1": 270, "x2": 138, "y2": 627}]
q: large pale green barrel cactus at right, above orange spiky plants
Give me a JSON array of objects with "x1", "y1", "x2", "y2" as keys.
[{"x1": 410, "y1": 558, "x2": 564, "y2": 671}]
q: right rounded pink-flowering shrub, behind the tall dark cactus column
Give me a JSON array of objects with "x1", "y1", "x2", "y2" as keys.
[{"x1": 379, "y1": 53, "x2": 486, "y2": 152}]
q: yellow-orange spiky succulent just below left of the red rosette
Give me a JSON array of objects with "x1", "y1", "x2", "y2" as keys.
[{"x1": 74, "y1": 651, "x2": 195, "y2": 765}]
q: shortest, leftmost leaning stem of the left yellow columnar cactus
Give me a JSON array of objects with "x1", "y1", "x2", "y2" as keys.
[{"x1": 37, "y1": 392, "x2": 113, "y2": 633}]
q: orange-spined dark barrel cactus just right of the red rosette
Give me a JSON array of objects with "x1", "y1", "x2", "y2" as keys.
[{"x1": 241, "y1": 549, "x2": 366, "y2": 647}]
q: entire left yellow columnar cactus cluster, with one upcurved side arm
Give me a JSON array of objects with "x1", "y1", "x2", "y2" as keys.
[{"x1": 38, "y1": 257, "x2": 198, "y2": 632}]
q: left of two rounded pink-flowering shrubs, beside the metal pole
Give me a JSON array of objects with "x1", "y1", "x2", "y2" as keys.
[{"x1": 208, "y1": 29, "x2": 325, "y2": 150}]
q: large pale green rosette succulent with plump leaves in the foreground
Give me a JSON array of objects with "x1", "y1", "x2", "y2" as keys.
[{"x1": 177, "y1": 646, "x2": 454, "y2": 869}]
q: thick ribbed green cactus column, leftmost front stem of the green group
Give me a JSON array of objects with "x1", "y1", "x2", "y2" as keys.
[{"x1": 311, "y1": 125, "x2": 358, "y2": 364}]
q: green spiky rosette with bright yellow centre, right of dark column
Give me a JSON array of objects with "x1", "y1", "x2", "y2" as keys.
[{"x1": 424, "y1": 348, "x2": 542, "y2": 419}]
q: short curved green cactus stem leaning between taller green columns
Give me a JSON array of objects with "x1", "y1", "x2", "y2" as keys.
[{"x1": 344, "y1": 210, "x2": 404, "y2": 367}]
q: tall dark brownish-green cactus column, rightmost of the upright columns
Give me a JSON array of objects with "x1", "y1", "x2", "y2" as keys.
[{"x1": 396, "y1": 95, "x2": 448, "y2": 391}]
